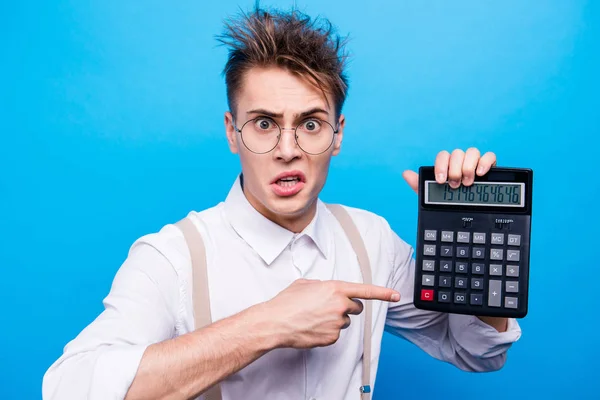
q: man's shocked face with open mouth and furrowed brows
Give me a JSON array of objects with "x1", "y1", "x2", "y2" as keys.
[{"x1": 225, "y1": 67, "x2": 345, "y2": 231}]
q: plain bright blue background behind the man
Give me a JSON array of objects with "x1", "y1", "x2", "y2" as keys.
[{"x1": 0, "y1": 0, "x2": 600, "y2": 400}]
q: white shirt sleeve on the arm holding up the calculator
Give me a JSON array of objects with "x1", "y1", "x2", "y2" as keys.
[{"x1": 386, "y1": 225, "x2": 521, "y2": 372}]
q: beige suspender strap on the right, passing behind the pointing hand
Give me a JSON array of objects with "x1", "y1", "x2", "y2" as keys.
[{"x1": 327, "y1": 204, "x2": 372, "y2": 400}]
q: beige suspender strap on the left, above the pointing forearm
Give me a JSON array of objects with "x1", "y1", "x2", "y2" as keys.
[{"x1": 175, "y1": 218, "x2": 222, "y2": 400}]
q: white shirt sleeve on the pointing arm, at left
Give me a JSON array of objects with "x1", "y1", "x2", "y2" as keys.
[{"x1": 42, "y1": 242, "x2": 179, "y2": 400}]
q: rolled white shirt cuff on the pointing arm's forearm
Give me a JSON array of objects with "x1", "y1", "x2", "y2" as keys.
[{"x1": 89, "y1": 345, "x2": 147, "y2": 400}]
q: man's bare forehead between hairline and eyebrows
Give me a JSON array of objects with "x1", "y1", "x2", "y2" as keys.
[{"x1": 237, "y1": 67, "x2": 332, "y2": 117}]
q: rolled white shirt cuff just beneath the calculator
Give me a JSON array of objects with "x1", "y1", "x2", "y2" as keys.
[{"x1": 449, "y1": 314, "x2": 521, "y2": 358}]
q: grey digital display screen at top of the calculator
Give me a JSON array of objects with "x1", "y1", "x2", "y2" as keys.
[{"x1": 425, "y1": 181, "x2": 525, "y2": 207}]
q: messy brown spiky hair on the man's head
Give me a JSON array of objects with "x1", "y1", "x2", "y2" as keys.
[{"x1": 217, "y1": 4, "x2": 348, "y2": 117}]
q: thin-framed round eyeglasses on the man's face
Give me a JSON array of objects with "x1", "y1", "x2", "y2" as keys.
[{"x1": 233, "y1": 117, "x2": 339, "y2": 155}]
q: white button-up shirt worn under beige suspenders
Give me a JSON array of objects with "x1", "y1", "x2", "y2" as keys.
[{"x1": 43, "y1": 178, "x2": 521, "y2": 400}]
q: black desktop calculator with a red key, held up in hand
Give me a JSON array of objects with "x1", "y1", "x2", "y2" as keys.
[{"x1": 413, "y1": 167, "x2": 533, "y2": 318}]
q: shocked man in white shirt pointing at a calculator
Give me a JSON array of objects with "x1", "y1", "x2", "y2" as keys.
[{"x1": 43, "y1": 6, "x2": 520, "y2": 400}]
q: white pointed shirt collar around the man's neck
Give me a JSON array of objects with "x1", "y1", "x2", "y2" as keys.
[{"x1": 225, "y1": 175, "x2": 329, "y2": 265}]
